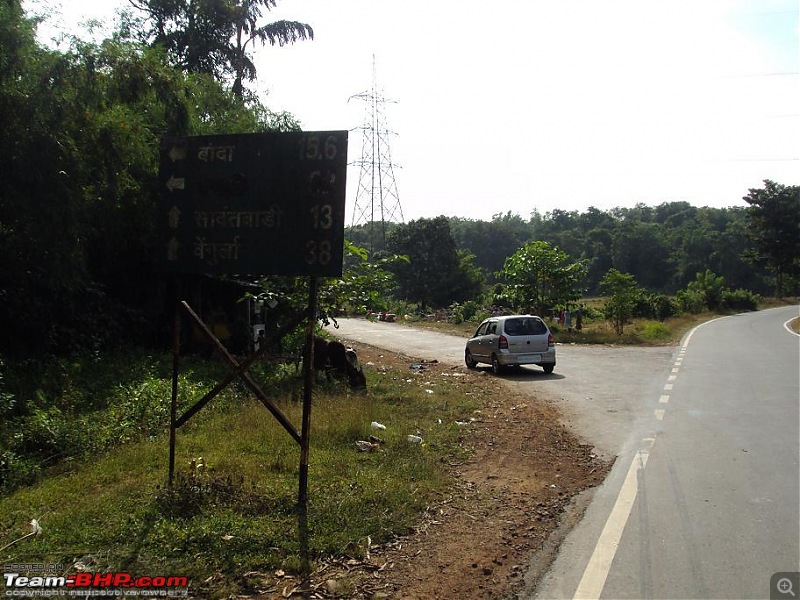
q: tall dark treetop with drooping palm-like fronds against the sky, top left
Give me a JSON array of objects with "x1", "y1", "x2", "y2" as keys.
[{"x1": 126, "y1": 0, "x2": 314, "y2": 97}]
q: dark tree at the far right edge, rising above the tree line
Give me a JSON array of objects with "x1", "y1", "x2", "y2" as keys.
[{"x1": 743, "y1": 179, "x2": 800, "y2": 298}]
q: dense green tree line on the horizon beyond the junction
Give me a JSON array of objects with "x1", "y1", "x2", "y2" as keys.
[{"x1": 348, "y1": 180, "x2": 800, "y2": 310}]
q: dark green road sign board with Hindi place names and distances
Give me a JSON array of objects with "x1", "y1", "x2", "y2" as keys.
[{"x1": 159, "y1": 131, "x2": 347, "y2": 277}]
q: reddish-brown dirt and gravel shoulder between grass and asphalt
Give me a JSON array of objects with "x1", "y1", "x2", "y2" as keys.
[{"x1": 260, "y1": 344, "x2": 610, "y2": 600}]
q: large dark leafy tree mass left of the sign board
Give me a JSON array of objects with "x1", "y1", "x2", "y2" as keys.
[{"x1": 0, "y1": 0, "x2": 296, "y2": 353}]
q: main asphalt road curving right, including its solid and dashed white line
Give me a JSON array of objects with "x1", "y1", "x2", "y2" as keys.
[{"x1": 535, "y1": 307, "x2": 800, "y2": 600}]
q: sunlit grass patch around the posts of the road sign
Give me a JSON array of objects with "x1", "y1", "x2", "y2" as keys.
[{"x1": 0, "y1": 352, "x2": 480, "y2": 597}]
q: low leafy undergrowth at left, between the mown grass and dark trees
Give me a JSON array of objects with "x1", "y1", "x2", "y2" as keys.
[{"x1": 0, "y1": 352, "x2": 250, "y2": 493}]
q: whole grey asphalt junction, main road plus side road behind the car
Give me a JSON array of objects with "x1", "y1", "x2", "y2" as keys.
[{"x1": 324, "y1": 307, "x2": 800, "y2": 600}]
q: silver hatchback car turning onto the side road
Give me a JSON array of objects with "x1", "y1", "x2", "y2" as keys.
[{"x1": 464, "y1": 315, "x2": 556, "y2": 374}]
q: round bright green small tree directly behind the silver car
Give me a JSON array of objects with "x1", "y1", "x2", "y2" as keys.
[{"x1": 499, "y1": 241, "x2": 587, "y2": 315}]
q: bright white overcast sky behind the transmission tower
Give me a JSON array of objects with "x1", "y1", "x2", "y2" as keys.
[{"x1": 29, "y1": 0, "x2": 800, "y2": 224}]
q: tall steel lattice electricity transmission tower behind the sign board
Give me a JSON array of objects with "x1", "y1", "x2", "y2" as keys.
[{"x1": 350, "y1": 55, "x2": 403, "y2": 251}]
